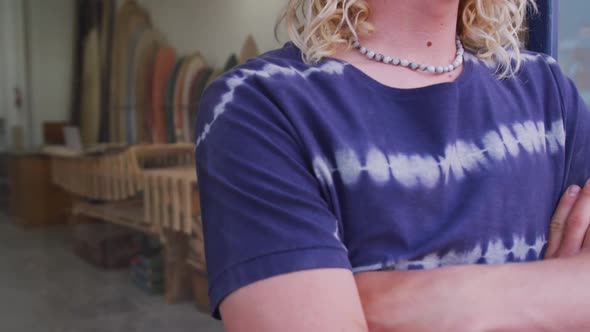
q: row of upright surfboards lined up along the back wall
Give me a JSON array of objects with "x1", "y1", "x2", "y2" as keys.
[{"x1": 81, "y1": 0, "x2": 258, "y2": 145}]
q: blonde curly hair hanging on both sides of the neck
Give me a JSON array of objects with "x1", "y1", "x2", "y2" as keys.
[{"x1": 277, "y1": 0, "x2": 537, "y2": 78}]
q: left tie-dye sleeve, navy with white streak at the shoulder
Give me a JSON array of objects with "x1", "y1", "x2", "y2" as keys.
[{"x1": 195, "y1": 77, "x2": 351, "y2": 318}]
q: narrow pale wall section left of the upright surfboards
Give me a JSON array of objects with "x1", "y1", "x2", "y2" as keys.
[{"x1": 27, "y1": 0, "x2": 75, "y2": 146}]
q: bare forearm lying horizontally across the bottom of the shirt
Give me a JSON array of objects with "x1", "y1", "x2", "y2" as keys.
[{"x1": 356, "y1": 254, "x2": 590, "y2": 332}]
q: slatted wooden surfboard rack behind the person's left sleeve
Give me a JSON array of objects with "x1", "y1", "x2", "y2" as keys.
[{"x1": 45, "y1": 143, "x2": 205, "y2": 303}]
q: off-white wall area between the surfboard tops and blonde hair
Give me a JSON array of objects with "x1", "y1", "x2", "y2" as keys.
[{"x1": 119, "y1": 0, "x2": 286, "y2": 66}]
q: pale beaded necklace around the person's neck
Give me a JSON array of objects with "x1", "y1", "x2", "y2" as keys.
[{"x1": 352, "y1": 37, "x2": 465, "y2": 74}]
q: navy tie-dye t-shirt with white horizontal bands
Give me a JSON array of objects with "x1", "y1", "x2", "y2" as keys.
[{"x1": 196, "y1": 44, "x2": 590, "y2": 313}]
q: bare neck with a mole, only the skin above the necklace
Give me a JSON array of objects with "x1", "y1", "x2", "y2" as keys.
[{"x1": 360, "y1": 0, "x2": 459, "y2": 65}]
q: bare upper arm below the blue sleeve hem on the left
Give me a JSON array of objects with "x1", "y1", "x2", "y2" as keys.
[{"x1": 220, "y1": 269, "x2": 367, "y2": 332}]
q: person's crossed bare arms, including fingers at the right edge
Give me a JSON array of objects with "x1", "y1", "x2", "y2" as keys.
[{"x1": 220, "y1": 185, "x2": 590, "y2": 332}]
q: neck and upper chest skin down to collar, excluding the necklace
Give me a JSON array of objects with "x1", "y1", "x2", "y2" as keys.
[{"x1": 333, "y1": 0, "x2": 463, "y2": 88}]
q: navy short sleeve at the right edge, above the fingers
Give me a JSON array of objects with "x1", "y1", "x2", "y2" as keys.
[{"x1": 551, "y1": 63, "x2": 590, "y2": 187}]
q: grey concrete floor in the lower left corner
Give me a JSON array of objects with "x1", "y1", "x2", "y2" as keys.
[{"x1": 0, "y1": 215, "x2": 223, "y2": 332}]
